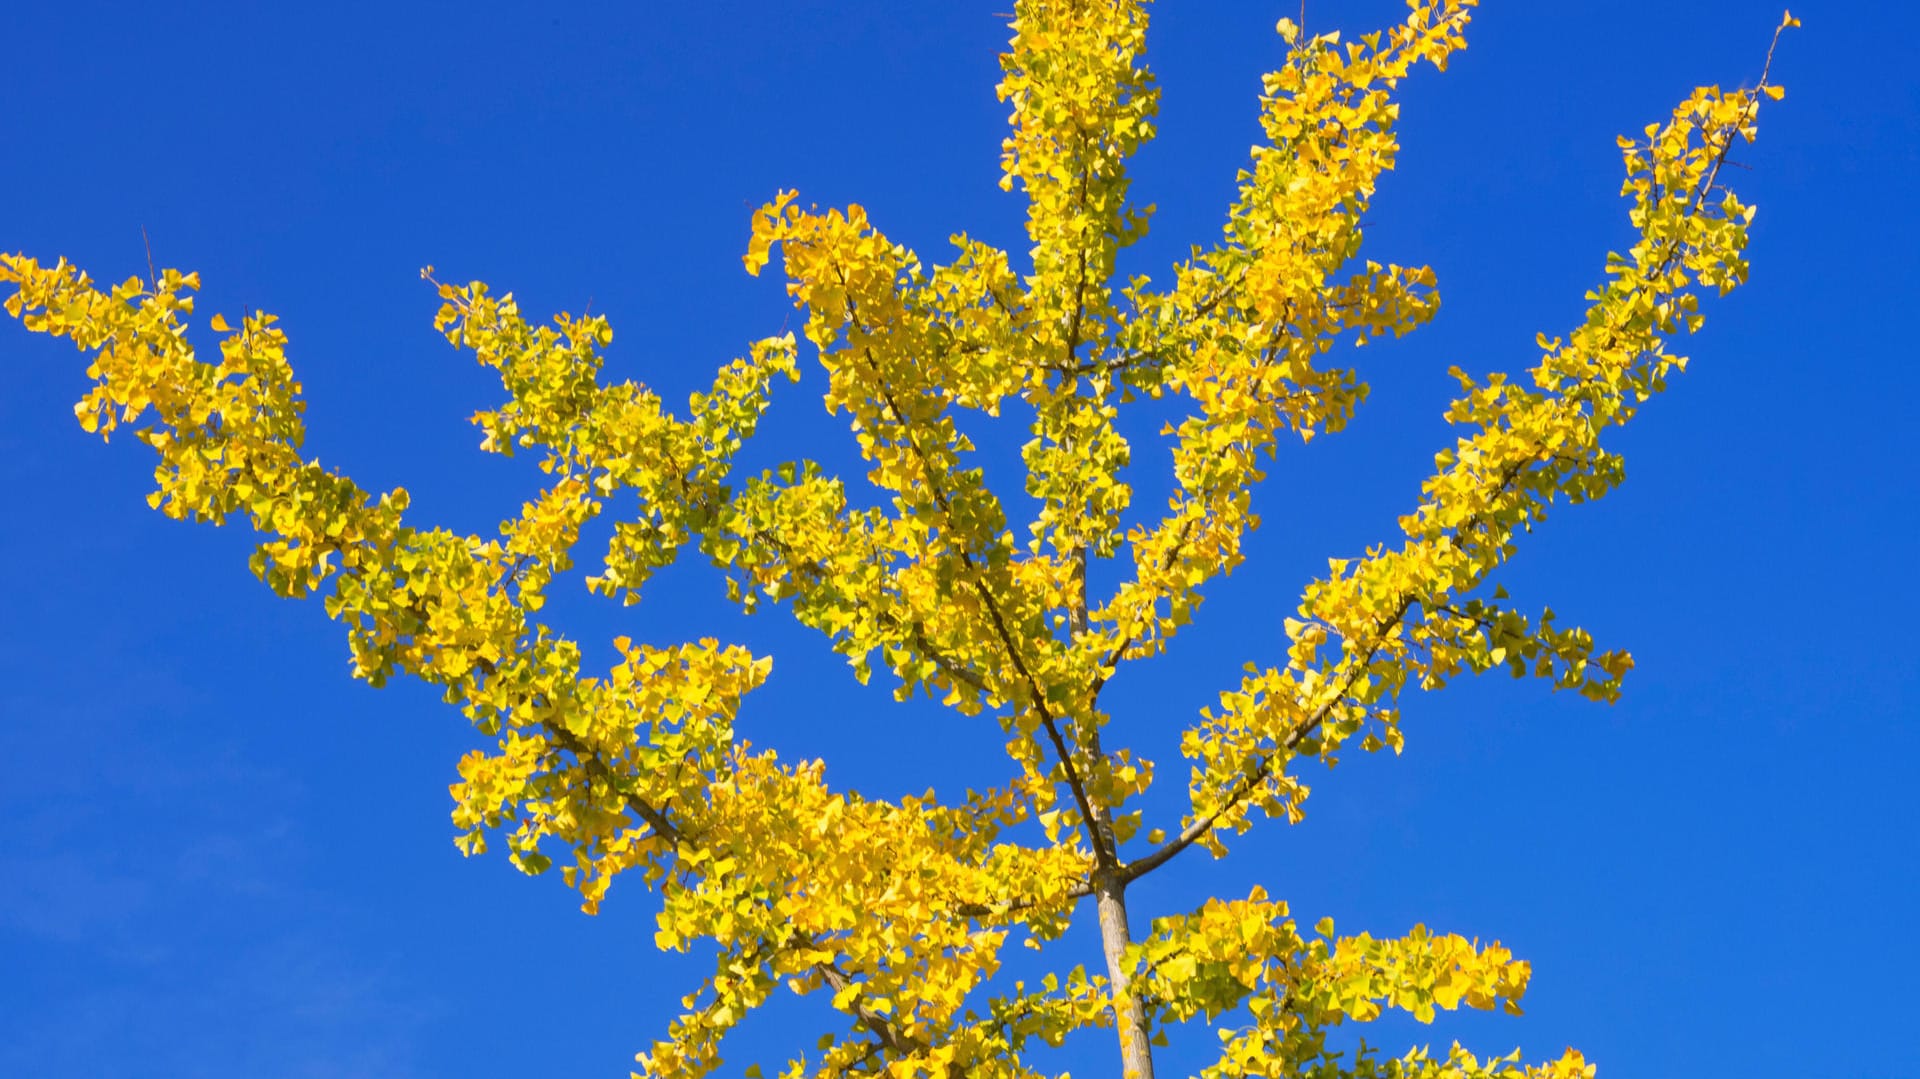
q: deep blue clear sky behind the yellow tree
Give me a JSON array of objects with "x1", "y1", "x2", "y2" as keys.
[{"x1": 0, "y1": 0, "x2": 1920, "y2": 1077}]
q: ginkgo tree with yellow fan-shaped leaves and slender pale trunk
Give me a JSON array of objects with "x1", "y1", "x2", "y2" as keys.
[{"x1": 0, "y1": 0, "x2": 1793, "y2": 1079}]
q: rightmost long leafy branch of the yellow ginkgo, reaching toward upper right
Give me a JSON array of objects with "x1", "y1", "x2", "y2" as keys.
[{"x1": 1127, "y1": 29, "x2": 1764, "y2": 877}]
